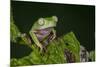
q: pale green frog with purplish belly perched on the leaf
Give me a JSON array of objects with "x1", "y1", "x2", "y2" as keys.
[{"x1": 22, "y1": 16, "x2": 58, "y2": 50}]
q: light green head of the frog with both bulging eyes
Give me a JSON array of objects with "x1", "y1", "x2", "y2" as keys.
[{"x1": 33, "y1": 16, "x2": 58, "y2": 29}]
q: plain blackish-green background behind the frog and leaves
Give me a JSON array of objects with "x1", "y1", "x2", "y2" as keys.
[{"x1": 11, "y1": 1, "x2": 95, "y2": 57}]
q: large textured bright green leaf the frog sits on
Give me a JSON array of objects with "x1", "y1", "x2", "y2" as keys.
[{"x1": 11, "y1": 32, "x2": 80, "y2": 66}]
